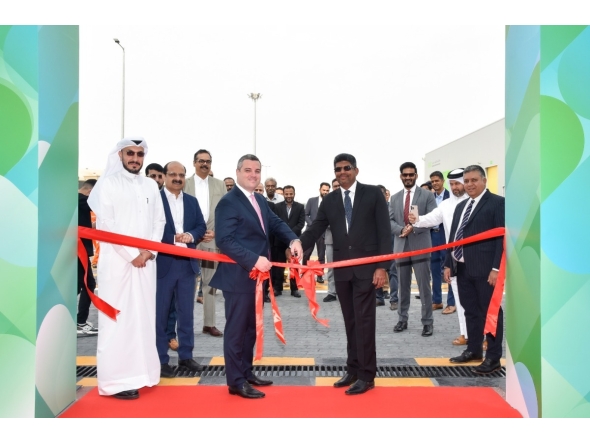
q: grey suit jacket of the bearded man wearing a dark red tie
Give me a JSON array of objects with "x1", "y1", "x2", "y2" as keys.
[{"x1": 389, "y1": 187, "x2": 436, "y2": 259}]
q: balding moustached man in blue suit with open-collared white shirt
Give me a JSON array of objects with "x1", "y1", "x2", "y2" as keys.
[{"x1": 156, "y1": 162, "x2": 207, "y2": 378}]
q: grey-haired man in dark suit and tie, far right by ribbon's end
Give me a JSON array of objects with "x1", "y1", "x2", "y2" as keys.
[{"x1": 444, "y1": 165, "x2": 504, "y2": 374}]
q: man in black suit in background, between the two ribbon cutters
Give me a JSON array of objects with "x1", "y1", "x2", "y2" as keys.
[{"x1": 270, "y1": 185, "x2": 305, "y2": 298}]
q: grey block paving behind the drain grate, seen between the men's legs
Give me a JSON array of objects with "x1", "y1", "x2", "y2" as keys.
[{"x1": 78, "y1": 285, "x2": 506, "y2": 364}]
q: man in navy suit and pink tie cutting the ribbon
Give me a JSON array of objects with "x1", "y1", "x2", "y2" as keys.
[{"x1": 211, "y1": 154, "x2": 303, "y2": 398}]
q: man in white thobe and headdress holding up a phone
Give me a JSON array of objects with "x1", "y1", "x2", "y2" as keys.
[{"x1": 408, "y1": 168, "x2": 468, "y2": 345}]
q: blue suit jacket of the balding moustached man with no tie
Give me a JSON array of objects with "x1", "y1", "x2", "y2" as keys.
[{"x1": 156, "y1": 190, "x2": 207, "y2": 278}]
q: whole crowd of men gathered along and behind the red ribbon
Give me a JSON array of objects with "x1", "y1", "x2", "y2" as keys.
[{"x1": 78, "y1": 138, "x2": 504, "y2": 399}]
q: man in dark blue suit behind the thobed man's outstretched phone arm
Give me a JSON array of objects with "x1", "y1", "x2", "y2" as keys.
[{"x1": 430, "y1": 171, "x2": 457, "y2": 314}]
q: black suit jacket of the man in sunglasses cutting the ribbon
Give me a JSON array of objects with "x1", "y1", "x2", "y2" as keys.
[{"x1": 301, "y1": 182, "x2": 391, "y2": 281}]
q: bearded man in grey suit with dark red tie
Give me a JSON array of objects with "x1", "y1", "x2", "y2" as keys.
[{"x1": 389, "y1": 162, "x2": 436, "y2": 336}]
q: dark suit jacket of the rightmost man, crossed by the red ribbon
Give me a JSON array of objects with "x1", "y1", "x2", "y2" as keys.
[{"x1": 445, "y1": 190, "x2": 505, "y2": 277}]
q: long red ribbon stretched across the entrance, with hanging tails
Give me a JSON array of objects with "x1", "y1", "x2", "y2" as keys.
[{"x1": 78, "y1": 227, "x2": 506, "y2": 346}]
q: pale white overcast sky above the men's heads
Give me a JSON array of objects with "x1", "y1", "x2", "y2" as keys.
[{"x1": 2, "y1": 0, "x2": 582, "y2": 203}]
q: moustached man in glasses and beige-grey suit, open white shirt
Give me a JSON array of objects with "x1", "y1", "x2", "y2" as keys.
[{"x1": 184, "y1": 150, "x2": 227, "y2": 337}]
